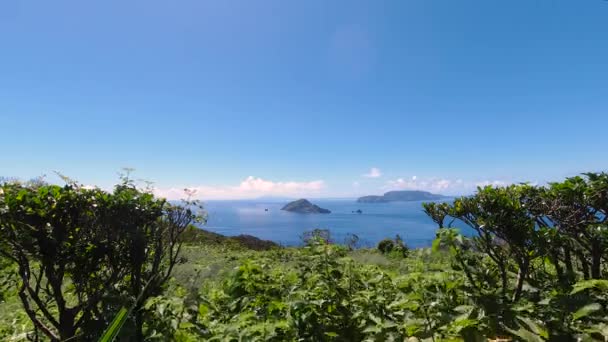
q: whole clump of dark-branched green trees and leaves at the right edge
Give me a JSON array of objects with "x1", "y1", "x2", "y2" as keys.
[{"x1": 427, "y1": 173, "x2": 608, "y2": 341}]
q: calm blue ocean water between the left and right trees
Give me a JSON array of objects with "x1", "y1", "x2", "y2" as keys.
[{"x1": 197, "y1": 200, "x2": 454, "y2": 247}]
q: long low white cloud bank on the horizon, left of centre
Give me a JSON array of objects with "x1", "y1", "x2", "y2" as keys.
[{"x1": 154, "y1": 176, "x2": 325, "y2": 200}]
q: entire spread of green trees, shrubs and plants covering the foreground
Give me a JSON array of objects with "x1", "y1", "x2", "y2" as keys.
[{"x1": 0, "y1": 173, "x2": 608, "y2": 341}]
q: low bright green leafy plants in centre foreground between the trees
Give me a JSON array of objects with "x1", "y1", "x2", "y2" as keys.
[{"x1": 133, "y1": 244, "x2": 481, "y2": 341}]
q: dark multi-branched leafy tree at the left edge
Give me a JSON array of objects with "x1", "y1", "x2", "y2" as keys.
[{"x1": 0, "y1": 178, "x2": 204, "y2": 341}]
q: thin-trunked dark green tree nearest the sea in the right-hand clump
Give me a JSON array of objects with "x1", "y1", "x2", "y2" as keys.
[{"x1": 427, "y1": 185, "x2": 538, "y2": 333}]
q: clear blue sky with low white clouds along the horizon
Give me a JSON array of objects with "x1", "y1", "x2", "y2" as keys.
[{"x1": 0, "y1": 0, "x2": 608, "y2": 199}]
